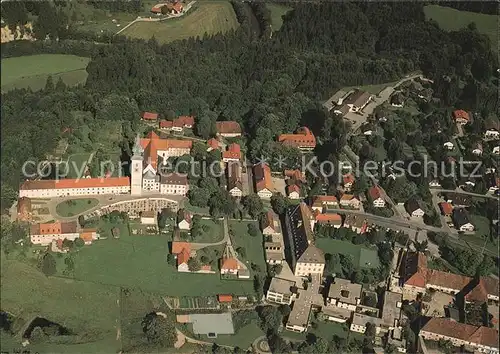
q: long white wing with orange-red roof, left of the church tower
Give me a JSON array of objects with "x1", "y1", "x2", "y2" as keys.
[{"x1": 19, "y1": 177, "x2": 130, "y2": 198}]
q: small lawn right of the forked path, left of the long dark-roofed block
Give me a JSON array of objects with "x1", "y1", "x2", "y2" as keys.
[{"x1": 228, "y1": 220, "x2": 266, "y2": 271}]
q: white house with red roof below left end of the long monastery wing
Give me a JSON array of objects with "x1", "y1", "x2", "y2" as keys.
[{"x1": 30, "y1": 221, "x2": 80, "y2": 246}]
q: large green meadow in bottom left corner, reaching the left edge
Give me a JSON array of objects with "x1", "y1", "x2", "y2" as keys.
[{"x1": 1, "y1": 256, "x2": 119, "y2": 342}]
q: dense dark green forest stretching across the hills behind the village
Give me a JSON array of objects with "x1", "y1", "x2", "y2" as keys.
[{"x1": 1, "y1": 2, "x2": 498, "y2": 208}]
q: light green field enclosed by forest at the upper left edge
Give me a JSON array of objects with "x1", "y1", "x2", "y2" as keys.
[{"x1": 1, "y1": 54, "x2": 90, "y2": 92}]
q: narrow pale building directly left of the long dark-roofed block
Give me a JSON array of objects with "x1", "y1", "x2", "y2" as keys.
[{"x1": 260, "y1": 210, "x2": 285, "y2": 264}]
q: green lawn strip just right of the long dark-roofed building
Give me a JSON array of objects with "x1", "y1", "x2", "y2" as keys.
[{"x1": 316, "y1": 238, "x2": 380, "y2": 268}]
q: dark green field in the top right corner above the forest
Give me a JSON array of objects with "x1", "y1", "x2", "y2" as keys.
[{"x1": 424, "y1": 5, "x2": 498, "y2": 53}]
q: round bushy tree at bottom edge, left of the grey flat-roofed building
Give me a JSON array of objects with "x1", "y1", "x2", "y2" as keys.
[{"x1": 142, "y1": 312, "x2": 177, "y2": 347}]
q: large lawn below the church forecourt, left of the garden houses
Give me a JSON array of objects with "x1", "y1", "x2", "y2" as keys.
[{"x1": 63, "y1": 224, "x2": 254, "y2": 296}]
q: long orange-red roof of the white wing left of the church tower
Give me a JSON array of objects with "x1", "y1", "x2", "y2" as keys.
[{"x1": 19, "y1": 177, "x2": 130, "y2": 190}]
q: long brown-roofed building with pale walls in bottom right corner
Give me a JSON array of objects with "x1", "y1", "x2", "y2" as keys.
[{"x1": 419, "y1": 317, "x2": 499, "y2": 353}]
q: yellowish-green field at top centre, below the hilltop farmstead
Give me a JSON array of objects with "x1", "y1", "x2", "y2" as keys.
[{"x1": 121, "y1": 1, "x2": 238, "y2": 43}]
